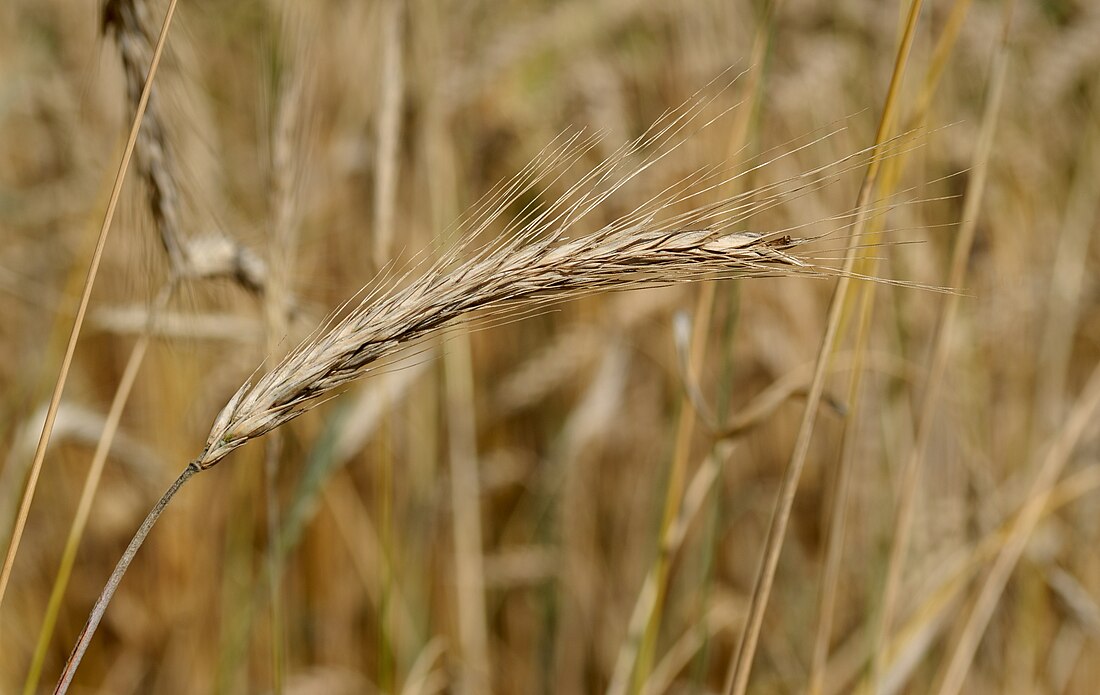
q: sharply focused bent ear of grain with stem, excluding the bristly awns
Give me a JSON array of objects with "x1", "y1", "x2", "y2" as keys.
[{"x1": 55, "y1": 229, "x2": 810, "y2": 693}]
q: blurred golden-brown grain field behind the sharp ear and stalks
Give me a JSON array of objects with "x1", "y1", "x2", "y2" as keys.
[{"x1": 0, "y1": 0, "x2": 1100, "y2": 695}]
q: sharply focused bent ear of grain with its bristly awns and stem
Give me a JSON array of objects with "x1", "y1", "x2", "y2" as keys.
[{"x1": 55, "y1": 92, "x2": 849, "y2": 693}]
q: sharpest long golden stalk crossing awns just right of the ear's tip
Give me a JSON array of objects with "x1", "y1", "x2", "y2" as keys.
[{"x1": 724, "y1": 0, "x2": 923, "y2": 695}]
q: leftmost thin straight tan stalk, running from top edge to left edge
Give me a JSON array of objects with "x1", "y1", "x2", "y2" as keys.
[{"x1": 0, "y1": 0, "x2": 178, "y2": 605}]
